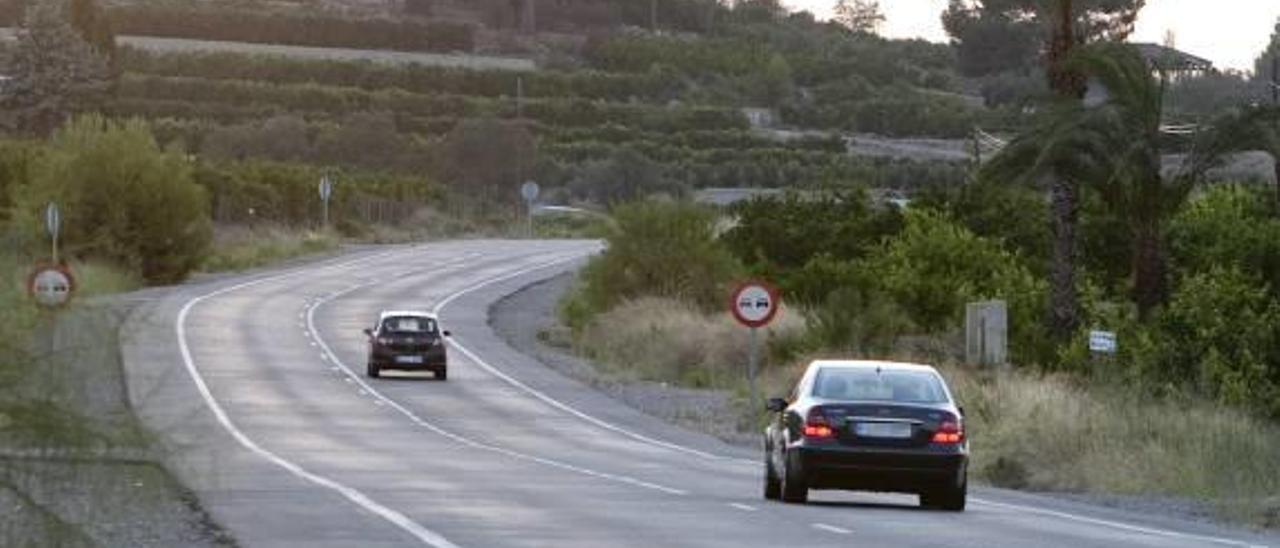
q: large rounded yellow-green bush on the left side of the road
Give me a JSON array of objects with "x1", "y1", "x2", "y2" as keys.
[{"x1": 19, "y1": 117, "x2": 210, "y2": 283}]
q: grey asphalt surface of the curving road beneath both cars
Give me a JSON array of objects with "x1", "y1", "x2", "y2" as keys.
[{"x1": 117, "y1": 241, "x2": 1280, "y2": 548}]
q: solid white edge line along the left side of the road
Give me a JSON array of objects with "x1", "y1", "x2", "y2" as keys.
[{"x1": 174, "y1": 247, "x2": 457, "y2": 548}]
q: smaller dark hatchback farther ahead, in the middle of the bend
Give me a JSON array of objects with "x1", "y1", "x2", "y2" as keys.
[{"x1": 365, "y1": 311, "x2": 449, "y2": 380}]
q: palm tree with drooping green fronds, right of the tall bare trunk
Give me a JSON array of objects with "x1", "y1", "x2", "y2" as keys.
[{"x1": 982, "y1": 42, "x2": 1274, "y2": 316}]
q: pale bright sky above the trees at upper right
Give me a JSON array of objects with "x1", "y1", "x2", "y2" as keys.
[{"x1": 785, "y1": 0, "x2": 1280, "y2": 70}]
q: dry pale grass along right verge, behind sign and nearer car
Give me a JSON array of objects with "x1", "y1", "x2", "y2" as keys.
[{"x1": 576, "y1": 298, "x2": 1280, "y2": 528}]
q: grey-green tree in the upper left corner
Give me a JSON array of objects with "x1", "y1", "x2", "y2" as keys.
[{"x1": 0, "y1": 0, "x2": 110, "y2": 136}]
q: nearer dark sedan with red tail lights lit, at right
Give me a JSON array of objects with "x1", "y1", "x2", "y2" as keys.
[{"x1": 764, "y1": 361, "x2": 969, "y2": 512}]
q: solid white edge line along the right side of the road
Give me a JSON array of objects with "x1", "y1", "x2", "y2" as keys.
[{"x1": 433, "y1": 249, "x2": 1274, "y2": 548}]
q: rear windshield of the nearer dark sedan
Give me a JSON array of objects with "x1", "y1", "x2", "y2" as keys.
[{"x1": 813, "y1": 367, "x2": 948, "y2": 403}]
